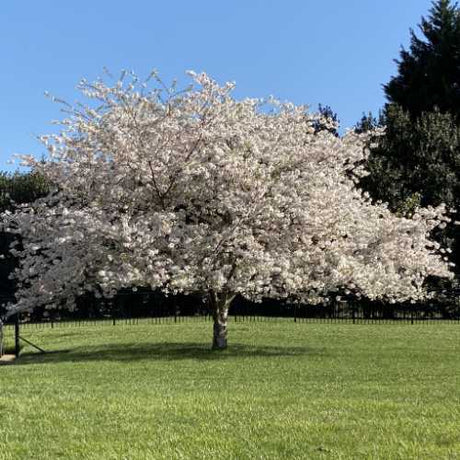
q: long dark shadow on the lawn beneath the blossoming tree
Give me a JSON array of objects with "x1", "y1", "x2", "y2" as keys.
[{"x1": 16, "y1": 342, "x2": 322, "y2": 365}]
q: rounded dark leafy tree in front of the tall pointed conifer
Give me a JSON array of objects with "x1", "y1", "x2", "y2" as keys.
[{"x1": 361, "y1": 105, "x2": 460, "y2": 210}]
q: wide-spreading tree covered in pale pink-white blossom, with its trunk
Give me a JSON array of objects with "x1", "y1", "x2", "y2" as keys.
[{"x1": 1, "y1": 73, "x2": 450, "y2": 348}]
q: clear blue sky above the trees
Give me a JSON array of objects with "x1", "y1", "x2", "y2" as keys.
[{"x1": 0, "y1": 0, "x2": 431, "y2": 170}]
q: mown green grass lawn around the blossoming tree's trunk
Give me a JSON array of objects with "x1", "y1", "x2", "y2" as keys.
[{"x1": 0, "y1": 321, "x2": 460, "y2": 460}]
